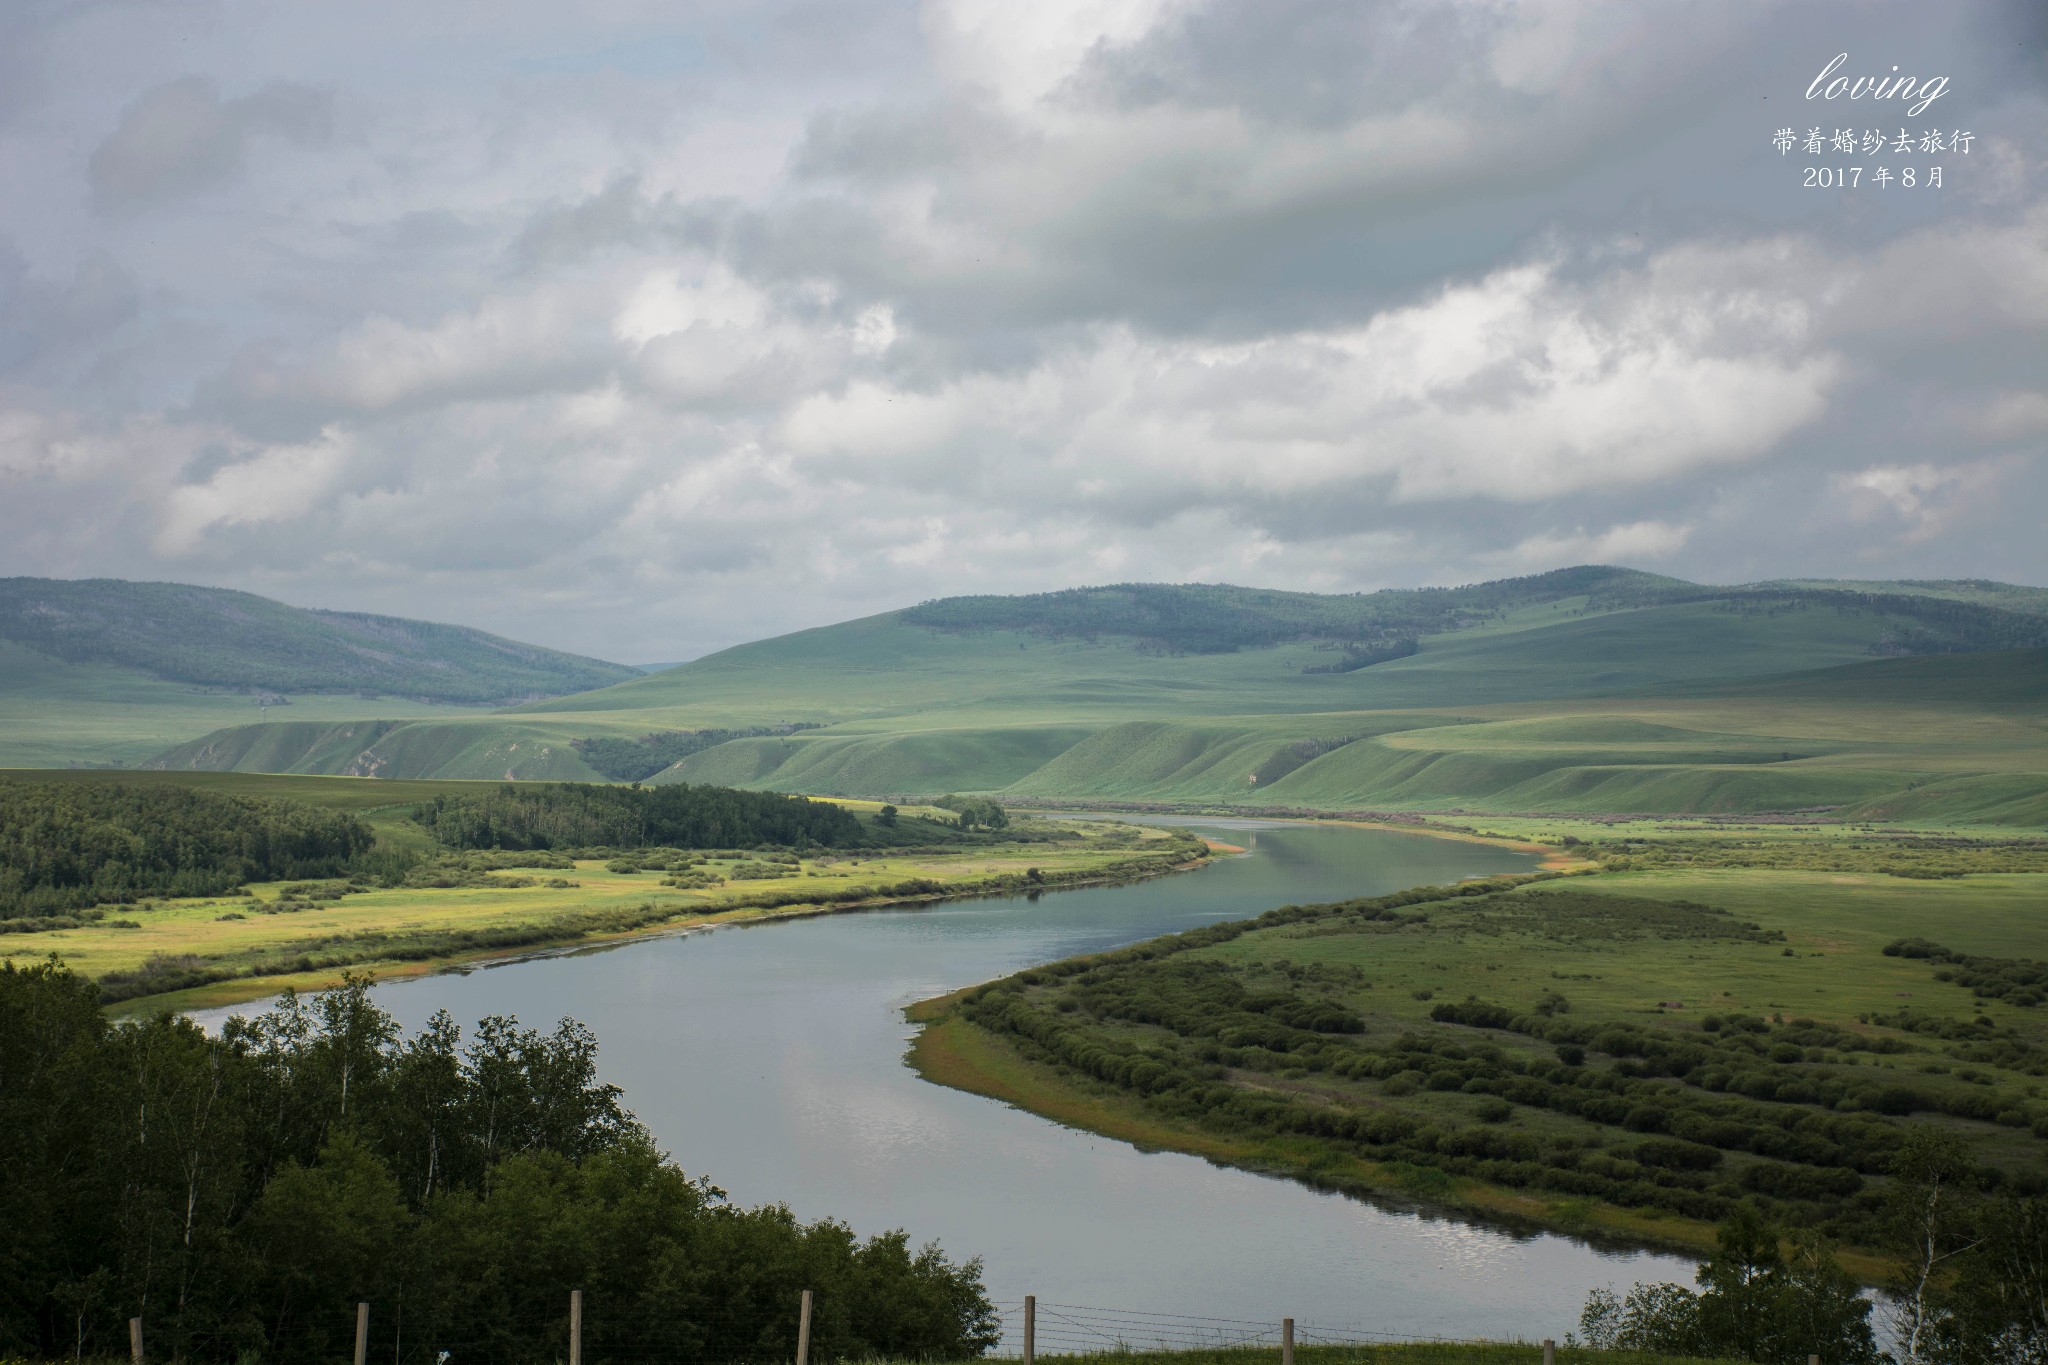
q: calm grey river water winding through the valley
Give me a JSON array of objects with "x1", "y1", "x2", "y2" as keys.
[{"x1": 203, "y1": 821, "x2": 1692, "y2": 1347}]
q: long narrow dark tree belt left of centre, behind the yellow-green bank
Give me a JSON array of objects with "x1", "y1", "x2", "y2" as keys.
[{"x1": 414, "y1": 784, "x2": 868, "y2": 849}]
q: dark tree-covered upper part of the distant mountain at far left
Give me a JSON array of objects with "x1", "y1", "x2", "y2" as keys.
[{"x1": 0, "y1": 577, "x2": 641, "y2": 706}]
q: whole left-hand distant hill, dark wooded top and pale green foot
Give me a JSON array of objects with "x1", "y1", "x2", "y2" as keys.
[{"x1": 0, "y1": 579, "x2": 635, "y2": 765}]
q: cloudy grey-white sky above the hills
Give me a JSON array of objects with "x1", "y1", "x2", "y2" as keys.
[{"x1": 0, "y1": 0, "x2": 2048, "y2": 663}]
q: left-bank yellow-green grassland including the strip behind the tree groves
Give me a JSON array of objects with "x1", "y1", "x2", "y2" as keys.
[{"x1": 0, "y1": 772, "x2": 1202, "y2": 1009}]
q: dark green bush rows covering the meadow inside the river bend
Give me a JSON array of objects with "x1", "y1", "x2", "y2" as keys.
[{"x1": 963, "y1": 884, "x2": 2048, "y2": 1238}]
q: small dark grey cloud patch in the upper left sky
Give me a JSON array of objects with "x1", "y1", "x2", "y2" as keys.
[{"x1": 86, "y1": 76, "x2": 332, "y2": 209}]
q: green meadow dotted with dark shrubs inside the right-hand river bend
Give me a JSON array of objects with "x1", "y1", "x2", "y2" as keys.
[{"x1": 913, "y1": 843, "x2": 2048, "y2": 1273}]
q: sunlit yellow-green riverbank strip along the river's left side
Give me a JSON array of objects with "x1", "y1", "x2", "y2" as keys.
[{"x1": 0, "y1": 823, "x2": 1208, "y2": 1015}]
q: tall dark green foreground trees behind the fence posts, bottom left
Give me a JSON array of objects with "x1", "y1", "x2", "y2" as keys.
[{"x1": 0, "y1": 964, "x2": 995, "y2": 1365}]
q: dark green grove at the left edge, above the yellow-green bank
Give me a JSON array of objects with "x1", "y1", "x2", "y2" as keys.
[{"x1": 0, "y1": 780, "x2": 373, "y2": 921}]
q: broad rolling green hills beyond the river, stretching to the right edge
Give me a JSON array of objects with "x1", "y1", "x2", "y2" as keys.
[{"x1": 132, "y1": 569, "x2": 2048, "y2": 825}]
